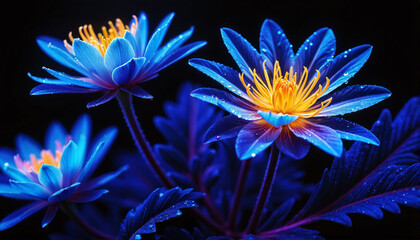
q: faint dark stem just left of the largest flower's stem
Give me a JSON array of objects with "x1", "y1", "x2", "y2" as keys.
[{"x1": 228, "y1": 158, "x2": 252, "y2": 230}]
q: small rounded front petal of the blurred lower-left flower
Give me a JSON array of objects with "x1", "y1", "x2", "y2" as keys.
[{"x1": 38, "y1": 164, "x2": 63, "y2": 192}]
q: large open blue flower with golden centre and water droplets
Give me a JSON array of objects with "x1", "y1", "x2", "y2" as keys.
[{"x1": 189, "y1": 19, "x2": 390, "y2": 159}]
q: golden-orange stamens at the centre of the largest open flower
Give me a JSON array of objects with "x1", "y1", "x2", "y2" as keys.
[{"x1": 239, "y1": 61, "x2": 332, "y2": 118}]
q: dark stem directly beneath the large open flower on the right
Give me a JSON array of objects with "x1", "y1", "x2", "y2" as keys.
[{"x1": 246, "y1": 144, "x2": 279, "y2": 234}]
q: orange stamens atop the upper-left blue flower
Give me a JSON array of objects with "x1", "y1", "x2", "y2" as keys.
[{"x1": 64, "y1": 16, "x2": 138, "y2": 56}]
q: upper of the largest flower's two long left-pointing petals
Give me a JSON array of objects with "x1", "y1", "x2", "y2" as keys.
[{"x1": 188, "y1": 58, "x2": 250, "y2": 100}]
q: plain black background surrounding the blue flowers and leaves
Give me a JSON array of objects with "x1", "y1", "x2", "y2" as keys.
[{"x1": 0, "y1": 0, "x2": 420, "y2": 239}]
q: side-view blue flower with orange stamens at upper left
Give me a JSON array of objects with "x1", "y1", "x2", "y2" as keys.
[{"x1": 28, "y1": 13, "x2": 206, "y2": 107}]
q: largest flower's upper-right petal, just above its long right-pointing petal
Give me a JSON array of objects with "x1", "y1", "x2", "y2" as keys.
[{"x1": 318, "y1": 44, "x2": 372, "y2": 96}]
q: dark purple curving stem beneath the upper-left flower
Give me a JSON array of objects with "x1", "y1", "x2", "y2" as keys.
[{"x1": 117, "y1": 91, "x2": 175, "y2": 188}]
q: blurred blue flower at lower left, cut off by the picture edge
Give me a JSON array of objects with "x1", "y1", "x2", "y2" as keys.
[{"x1": 0, "y1": 115, "x2": 126, "y2": 230}]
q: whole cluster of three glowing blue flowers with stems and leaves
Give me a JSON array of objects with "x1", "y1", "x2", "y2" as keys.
[{"x1": 0, "y1": 8, "x2": 420, "y2": 240}]
